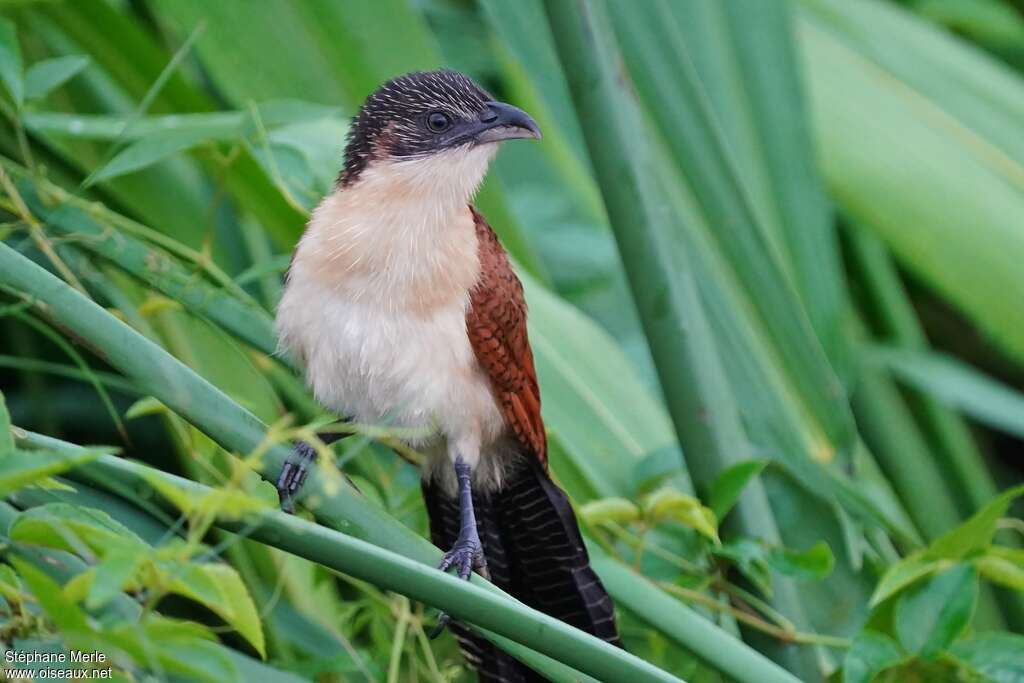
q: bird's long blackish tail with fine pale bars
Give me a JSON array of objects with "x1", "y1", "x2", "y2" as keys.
[{"x1": 423, "y1": 458, "x2": 620, "y2": 683}]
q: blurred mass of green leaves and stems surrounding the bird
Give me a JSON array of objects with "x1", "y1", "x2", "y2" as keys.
[{"x1": 0, "y1": 0, "x2": 1024, "y2": 682}]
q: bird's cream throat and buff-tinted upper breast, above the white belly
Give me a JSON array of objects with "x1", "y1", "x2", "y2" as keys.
[{"x1": 292, "y1": 144, "x2": 498, "y2": 309}]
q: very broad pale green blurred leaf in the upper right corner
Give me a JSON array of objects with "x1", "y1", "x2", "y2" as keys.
[{"x1": 800, "y1": 0, "x2": 1024, "y2": 366}]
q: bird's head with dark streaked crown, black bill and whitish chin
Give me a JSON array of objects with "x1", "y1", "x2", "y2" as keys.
[{"x1": 338, "y1": 71, "x2": 541, "y2": 201}]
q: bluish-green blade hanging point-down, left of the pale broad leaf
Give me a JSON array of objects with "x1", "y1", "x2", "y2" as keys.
[{"x1": 668, "y1": 0, "x2": 849, "y2": 379}]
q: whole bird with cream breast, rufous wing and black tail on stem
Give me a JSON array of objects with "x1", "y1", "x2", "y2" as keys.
[{"x1": 274, "y1": 70, "x2": 621, "y2": 682}]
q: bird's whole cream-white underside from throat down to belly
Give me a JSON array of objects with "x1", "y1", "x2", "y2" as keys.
[{"x1": 276, "y1": 145, "x2": 506, "y2": 489}]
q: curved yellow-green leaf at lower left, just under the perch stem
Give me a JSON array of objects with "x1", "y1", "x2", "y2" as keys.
[{"x1": 162, "y1": 562, "x2": 266, "y2": 656}]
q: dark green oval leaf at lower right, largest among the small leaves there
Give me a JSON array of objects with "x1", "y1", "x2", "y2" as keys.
[{"x1": 895, "y1": 564, "x2": 978, "y2": 658}]
